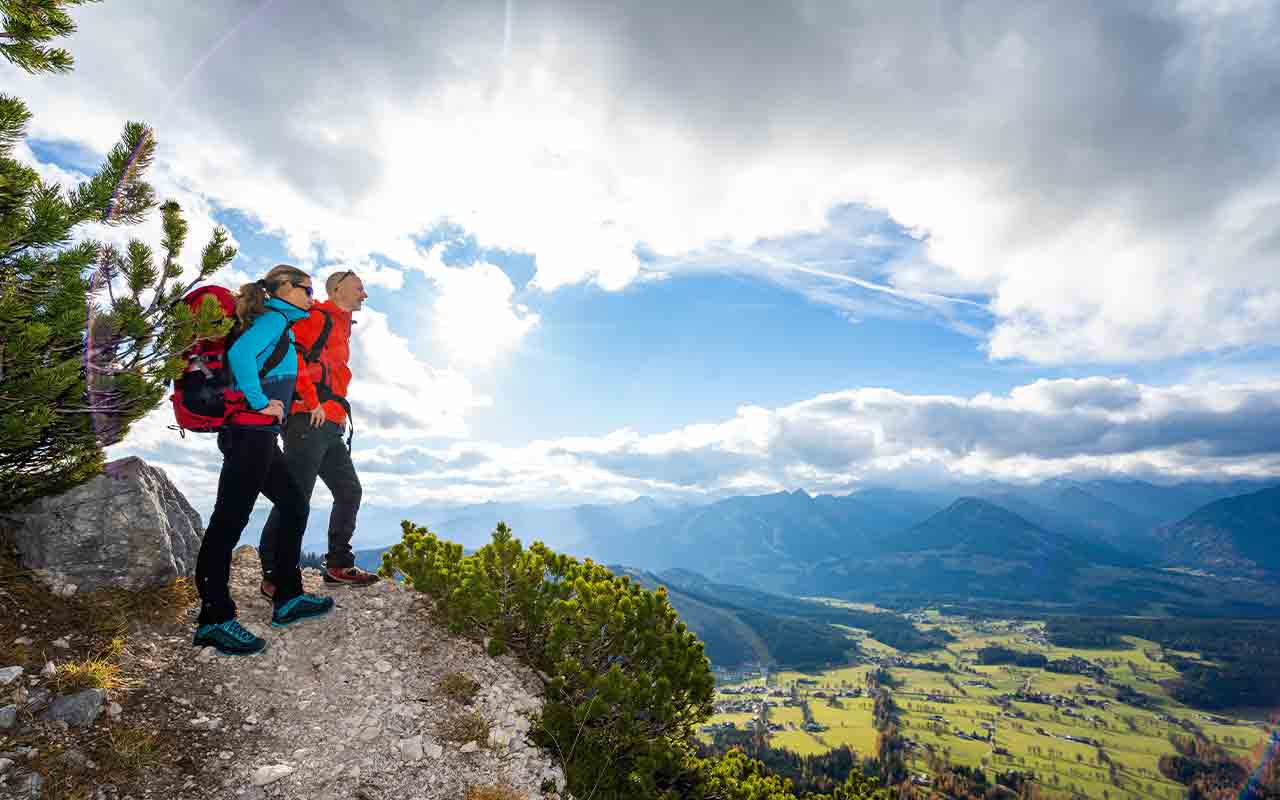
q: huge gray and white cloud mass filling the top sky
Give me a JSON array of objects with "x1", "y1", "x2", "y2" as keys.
[{"x1": 17, "y1": 0, "x2": 1280, "y2": 362}]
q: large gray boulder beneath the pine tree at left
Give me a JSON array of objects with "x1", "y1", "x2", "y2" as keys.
[{"x1": 4, "y1": 457, "x2": 204, "y2": 591}]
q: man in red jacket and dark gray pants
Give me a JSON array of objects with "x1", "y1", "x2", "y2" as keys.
[{"x1": 259, "y1": 271, "x2": 378, "y2": 596}]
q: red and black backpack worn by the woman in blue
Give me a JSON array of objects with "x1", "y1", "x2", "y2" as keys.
[{"x1": 170, "y1": 285, "x2": 291, "y2": 433}]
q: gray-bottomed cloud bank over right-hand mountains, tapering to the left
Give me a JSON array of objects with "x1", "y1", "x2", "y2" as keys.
[{"x1": 554, "y1": 378, "x2": 1280, "y2": 492}]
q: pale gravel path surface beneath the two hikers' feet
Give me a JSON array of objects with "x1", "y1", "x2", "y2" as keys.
[{"x1": 202, "y1": 547, "x2": 564, "y2": 800}]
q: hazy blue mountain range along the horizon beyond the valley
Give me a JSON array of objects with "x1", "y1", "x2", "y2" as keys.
[{"x1": 330, "y1": 480, "x2": 1280, "y2": 616}]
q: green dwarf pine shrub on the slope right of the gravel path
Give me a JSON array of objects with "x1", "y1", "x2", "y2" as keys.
[{"x1": 379, "y1": 521, "x2": 874, "y2": 800}]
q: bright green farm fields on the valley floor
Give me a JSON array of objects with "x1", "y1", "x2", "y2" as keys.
[{"x1": 707, "y1": 613, "x2": 1270, "y2": 800}]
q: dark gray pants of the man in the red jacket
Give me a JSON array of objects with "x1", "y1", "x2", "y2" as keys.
[{"x1": 257, "y1": 413, "x2": 362, "y2": 573}]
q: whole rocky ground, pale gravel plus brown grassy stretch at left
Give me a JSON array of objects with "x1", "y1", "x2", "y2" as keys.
[{"x1": 0, "y1": 547, "x2": 564, "y2": 800}]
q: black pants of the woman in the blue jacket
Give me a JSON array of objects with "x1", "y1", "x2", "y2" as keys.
[{"x1": 196, "y1": 428, "x2": 310, "y2": 625}]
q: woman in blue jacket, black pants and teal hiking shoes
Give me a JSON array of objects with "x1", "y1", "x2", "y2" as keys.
[{"x1": 192, "y1": 264, "x2": 333, "y2": 655}]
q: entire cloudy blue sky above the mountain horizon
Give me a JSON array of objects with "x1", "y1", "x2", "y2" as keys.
[{"x1": 5, "y1": 0, "x2": 1280, "y2": 538}]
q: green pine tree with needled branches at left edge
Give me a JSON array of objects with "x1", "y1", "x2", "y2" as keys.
[{"x1": 0, "y1": 0, "x2": 236, "y2": 512}]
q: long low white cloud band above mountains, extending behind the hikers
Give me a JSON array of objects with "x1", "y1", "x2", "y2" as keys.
[{"x1": 104, "y1": 378, "x2": 1280, "y2": 513}]
